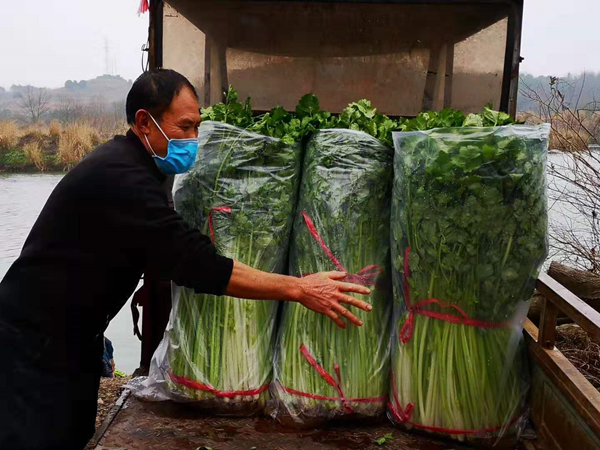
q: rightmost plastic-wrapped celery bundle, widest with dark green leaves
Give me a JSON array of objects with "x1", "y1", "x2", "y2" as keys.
[{"x1": 388, "y1": 125, "x2": 549, "y2": 439}]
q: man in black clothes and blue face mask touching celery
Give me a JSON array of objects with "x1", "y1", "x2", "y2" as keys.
[{"x1": 0, "y1": 70, "x2": 370, "y2": 450}]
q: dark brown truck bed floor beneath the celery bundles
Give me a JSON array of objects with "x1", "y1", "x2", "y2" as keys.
[{"x1": 88, "y1": 391, "x2": 532, "y2": 450}]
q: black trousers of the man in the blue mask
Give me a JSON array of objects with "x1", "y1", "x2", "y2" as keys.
[{"x1": 0, "y1": 324, "x2": 101, "y2": 450}]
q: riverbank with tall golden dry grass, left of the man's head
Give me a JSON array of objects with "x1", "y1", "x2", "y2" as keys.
[{"x1": 0, "y1": 120, "x2": 118, "y2": 173}]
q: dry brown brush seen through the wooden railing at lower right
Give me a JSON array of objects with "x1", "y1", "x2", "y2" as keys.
[{"x1": 556, "y1": 324, "x2": 600, "y2": 390}]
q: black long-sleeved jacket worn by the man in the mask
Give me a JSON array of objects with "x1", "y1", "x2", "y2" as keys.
[{"x1": 0, "y1": 131, "x2": 233, "y2": 371}]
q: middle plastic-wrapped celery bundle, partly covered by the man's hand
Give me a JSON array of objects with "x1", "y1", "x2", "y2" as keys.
[{"x1": 272, "y1": 129, "x2": 393, "y2": 426}]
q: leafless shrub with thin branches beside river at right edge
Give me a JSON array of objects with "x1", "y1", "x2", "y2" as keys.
[{"x1": 521, "y1": 77, "x2": 600, "y2": 273}]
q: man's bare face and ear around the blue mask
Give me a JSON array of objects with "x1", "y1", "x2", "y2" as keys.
[{"x1": 142, "y1": 87, "x2": 201, "y2": 157}]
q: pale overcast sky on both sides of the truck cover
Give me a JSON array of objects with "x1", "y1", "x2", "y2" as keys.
[{"x1": 0, "y1": 0, "x2": 600, "y2": 88}]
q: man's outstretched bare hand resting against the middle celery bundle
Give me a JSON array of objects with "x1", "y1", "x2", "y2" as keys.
[{"x1": 298, "y1": 272, "x2": 373, "y2": 328}]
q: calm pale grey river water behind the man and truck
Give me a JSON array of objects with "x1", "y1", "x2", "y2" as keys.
[{"x1": 0, "y1": 154, "x2": 592, "y2": 373}]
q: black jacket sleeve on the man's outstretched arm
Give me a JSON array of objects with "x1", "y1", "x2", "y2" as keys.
[{"x1": 99, "y1": 159, "x2": 233, "y2": 295}]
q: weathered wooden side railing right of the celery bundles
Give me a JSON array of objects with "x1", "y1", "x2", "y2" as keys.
[{"x1": 525, "y1": 274, "x2": 600, "y2": 449}]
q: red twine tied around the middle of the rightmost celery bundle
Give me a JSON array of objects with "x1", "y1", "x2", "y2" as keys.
[{"x1": 398, "y1": 247, "x2": 506, "y2": 344}]
